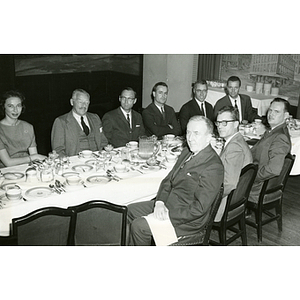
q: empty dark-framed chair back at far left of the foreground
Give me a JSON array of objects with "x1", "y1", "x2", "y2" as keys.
[{"x1": 12, "y1": 207, "x2": 74, "y2": 246}]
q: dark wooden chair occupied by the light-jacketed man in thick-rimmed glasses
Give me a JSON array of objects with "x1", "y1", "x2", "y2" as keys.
[{"x1": 209, "y1": 163, "x2": 258, "y2": 246}]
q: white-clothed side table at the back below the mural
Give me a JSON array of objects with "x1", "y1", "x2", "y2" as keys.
[{"x1": 206, "y1": 87, "x2": 288, "y2": 116}]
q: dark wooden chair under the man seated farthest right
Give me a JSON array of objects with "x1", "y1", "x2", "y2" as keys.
[{"x1": 246, "y1": 153, "x2": 295, "y2": 242}]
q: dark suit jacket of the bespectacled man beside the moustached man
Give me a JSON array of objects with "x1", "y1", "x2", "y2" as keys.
[{"x1": 102, "y1": 107, "x2": 145, "y2": 147}]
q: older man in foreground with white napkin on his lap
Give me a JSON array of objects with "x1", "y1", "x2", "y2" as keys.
[{"x1": 128, "y1": 116, "x2": 224, "y2": 245}]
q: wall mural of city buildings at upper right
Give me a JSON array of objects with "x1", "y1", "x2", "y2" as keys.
[{"x1": 220, "y1": 54, "x2": 300, "y2": 106}]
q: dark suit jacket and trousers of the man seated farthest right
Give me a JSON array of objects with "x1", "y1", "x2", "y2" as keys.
[{"x1": 249, "y1": 123, "x2": 291, "y2": 202}]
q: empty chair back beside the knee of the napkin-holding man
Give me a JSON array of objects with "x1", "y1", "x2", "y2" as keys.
[{"x1": 69, "y1": 200, "x2": 127, "y2": 246}]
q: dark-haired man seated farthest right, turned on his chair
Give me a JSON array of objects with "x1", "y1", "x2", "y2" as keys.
[{"x1": 248, "y1": 98, "x2": 291, "y2": 203}]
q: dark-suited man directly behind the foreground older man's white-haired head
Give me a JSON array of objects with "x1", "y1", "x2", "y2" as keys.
[{"x1": 179, "y1": 80, "x2": 214, "y2": 133}]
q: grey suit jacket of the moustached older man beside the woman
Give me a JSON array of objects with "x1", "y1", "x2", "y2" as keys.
[{"x1": 51, "y1": 111, "x2": 107, "y2": 156}]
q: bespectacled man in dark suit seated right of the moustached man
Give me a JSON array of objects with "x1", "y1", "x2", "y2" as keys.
[{"x1": 102, "y1": 87, "x2": 145, "y2": 147}]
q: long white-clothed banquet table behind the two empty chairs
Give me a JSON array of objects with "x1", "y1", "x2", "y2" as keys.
[{"x1": 0, "y1": 149, "x2": 174, "y2": 236}]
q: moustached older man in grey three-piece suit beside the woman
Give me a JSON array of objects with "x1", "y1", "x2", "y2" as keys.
[{"x1": 51, "y1": 89, "x2": 107, "y2": 156}]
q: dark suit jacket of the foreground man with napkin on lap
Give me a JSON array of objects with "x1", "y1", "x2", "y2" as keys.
[{"x1": 156, "y1": 145, "x2": 224, "y2": 236}]
